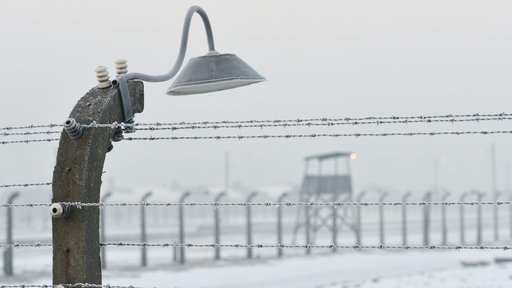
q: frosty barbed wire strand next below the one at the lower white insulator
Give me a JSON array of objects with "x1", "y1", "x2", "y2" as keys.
[{"x1": 0, "y1": 242, "x2": 512, "y2": 251}]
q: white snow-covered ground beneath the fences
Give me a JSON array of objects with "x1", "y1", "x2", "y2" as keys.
[{"x1": 0, "y1": 248, "x2": 512, "y2": 288}]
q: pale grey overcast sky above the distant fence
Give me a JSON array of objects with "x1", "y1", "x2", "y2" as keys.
[{"x1": 0, "y1": 0, "x2": 512, "y2": 200}]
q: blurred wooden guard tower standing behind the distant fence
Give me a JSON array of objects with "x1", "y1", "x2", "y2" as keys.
[{"x1": 293, "y1": 152, "x2": 355, "y2": 244}]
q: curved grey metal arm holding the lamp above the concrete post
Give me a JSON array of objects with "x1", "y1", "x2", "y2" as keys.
[{"x1": 113, "y1": 6, "x2": 215, "y2": 122}]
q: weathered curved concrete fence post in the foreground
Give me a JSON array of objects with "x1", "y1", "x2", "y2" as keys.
[{"x1": 52, "y1": 81, "x2": 144, "y2": 285}]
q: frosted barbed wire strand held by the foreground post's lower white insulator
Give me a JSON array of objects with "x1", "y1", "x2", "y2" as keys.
[{"x1": 0, "y1": 201, "x2": 512, "y2": 209}]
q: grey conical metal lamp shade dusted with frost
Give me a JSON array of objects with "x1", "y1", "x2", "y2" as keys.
[{"x1": 167, "y1": 52, "x2": 265, "y2": 95}]
